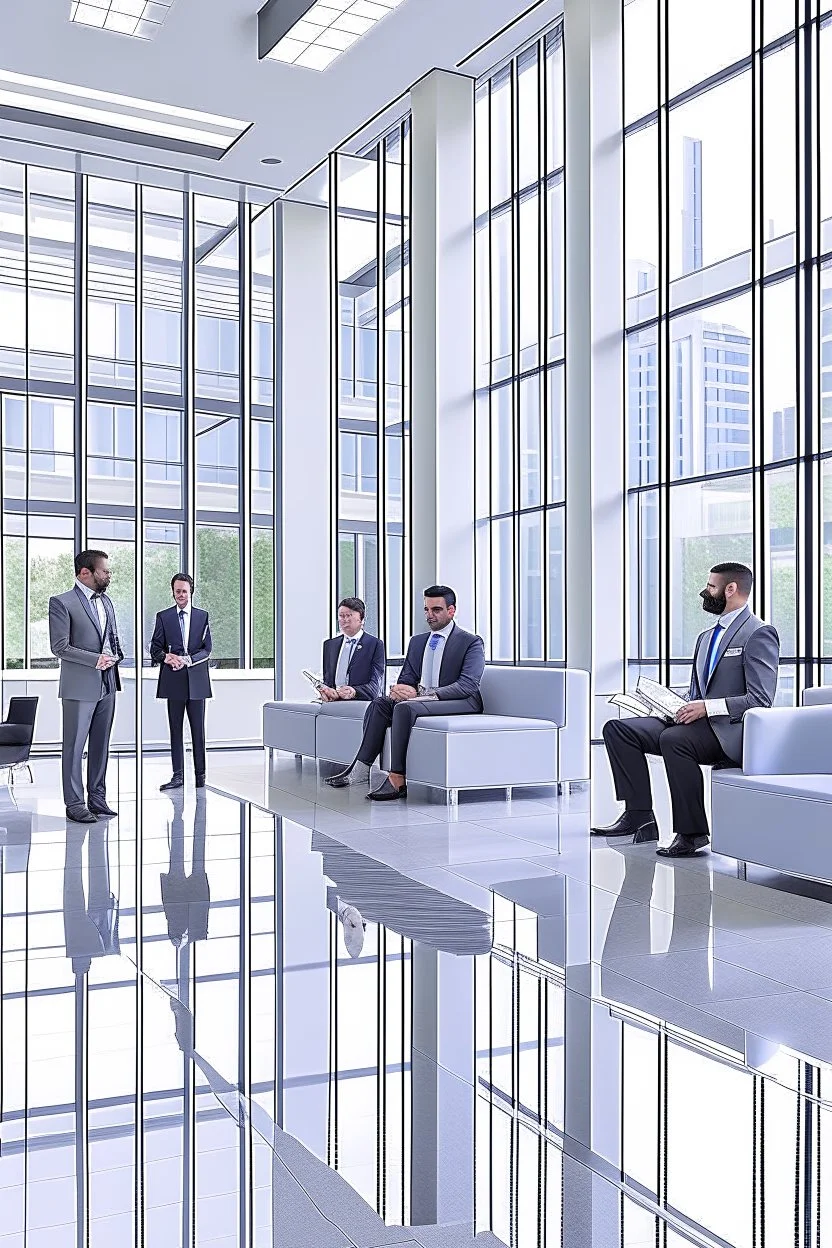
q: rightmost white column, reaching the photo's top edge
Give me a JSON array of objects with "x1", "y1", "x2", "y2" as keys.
[{"x1": 564, "y1": 0, "x2": 626, "y2": 736}]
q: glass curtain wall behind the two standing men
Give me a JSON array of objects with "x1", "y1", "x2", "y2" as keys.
[{"x1": 0, "y1": 161, "x2": 274, "y2": 688}]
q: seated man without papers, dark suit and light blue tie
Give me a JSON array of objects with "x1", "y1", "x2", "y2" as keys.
[{"x1": 327, "y1": 585, "x2": 485, "y2": 801}]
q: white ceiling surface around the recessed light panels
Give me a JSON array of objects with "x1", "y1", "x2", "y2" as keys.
[{"x1": 0, "y1": 0, "x2": 550, "y2": 190}]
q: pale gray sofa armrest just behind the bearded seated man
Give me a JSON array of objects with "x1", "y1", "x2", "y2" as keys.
[{"x1": 742, "y1": 706, "x2": 832, "y2": 776}]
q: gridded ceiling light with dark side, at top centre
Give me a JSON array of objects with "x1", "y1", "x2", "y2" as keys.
[{"x1": 258, "y1": 0, "x2": 402, "y2": 70}]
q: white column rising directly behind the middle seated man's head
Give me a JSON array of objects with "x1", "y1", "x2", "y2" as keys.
[{"x1": 410, "y1": 70, "x2": 474, "y2": 630}]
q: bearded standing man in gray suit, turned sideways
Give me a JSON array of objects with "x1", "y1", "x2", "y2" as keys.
[{"x1": 49, "y1": 550, "x2": 123, "y2": 824}]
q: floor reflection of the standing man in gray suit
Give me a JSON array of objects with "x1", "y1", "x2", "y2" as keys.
[{"x1": 64, "y1": 822, "x2": 121, "y2": 975}]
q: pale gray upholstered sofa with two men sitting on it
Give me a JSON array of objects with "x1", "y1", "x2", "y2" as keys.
[{"x1": 263, "y1": 668, "x2": 589, "y2": 800}]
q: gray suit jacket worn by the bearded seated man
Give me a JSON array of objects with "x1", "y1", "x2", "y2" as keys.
[{"x1": 687, "y1": 607, "x2": 780, "y2": 764}]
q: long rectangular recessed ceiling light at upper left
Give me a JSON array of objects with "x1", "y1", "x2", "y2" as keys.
[{"x1": 0, "y1": 70, "x2": 251, "y2": 160}]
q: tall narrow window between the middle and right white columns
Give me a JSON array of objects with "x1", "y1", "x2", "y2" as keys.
[{"x1": 474, "y1": 26, "x2": 566, "y2": 663}]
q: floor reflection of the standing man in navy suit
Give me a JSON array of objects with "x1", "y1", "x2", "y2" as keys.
[{"x1": 160, "y1": 790, "x2": 211, "y2": 948}]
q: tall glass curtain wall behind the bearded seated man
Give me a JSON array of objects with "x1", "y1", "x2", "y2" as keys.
[{"x1": 624, "y1": 0, "x2": 832, "y2": 704}]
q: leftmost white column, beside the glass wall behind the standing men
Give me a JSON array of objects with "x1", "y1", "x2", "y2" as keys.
[{"x1": 276, "y1": 201, "x2": 333, "y2": 701}]
